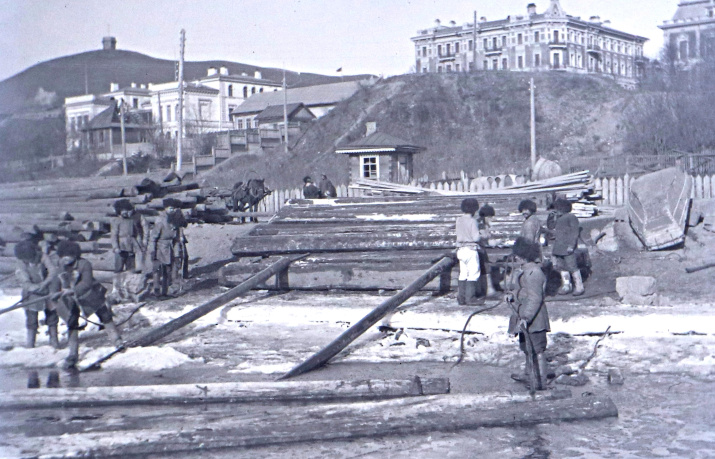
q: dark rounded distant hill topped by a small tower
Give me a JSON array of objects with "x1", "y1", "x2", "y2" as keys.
[{"x1": 0, "y1": 50, "x2": 370, "y2": 114}]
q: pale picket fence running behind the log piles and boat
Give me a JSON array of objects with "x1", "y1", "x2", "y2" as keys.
[{"x1": 248, "y1": 174, "x2": 715, "y2": 213}]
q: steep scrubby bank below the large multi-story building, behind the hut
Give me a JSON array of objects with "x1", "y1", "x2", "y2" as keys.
[{"x1": 204, "y1": 72, "x2": 637, "y2": 188}]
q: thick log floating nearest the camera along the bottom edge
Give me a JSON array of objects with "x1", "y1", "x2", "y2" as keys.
[{"x1": 4, "y1": 394, "x2": 618, "y2": 458}]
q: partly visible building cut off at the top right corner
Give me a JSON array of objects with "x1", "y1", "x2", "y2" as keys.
[{"x1": 658, "y1": 0, "x2": 715, "y2": 66}]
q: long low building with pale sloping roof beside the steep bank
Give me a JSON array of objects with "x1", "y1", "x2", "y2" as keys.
[{"x1": 231, "y1": 81, "x2": 368, "y2": 129}]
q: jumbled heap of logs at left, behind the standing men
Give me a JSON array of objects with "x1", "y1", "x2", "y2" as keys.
[{"x1": 0, "y1": 175, "x2": 238, "y2": 283}]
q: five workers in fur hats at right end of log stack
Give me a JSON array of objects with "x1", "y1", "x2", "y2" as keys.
[{"x1": 456, "y1": 198, "x2": 584, "y2": 389}]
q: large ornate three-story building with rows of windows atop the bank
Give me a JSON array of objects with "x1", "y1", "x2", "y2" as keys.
[{"x1": 412, "y1": 0, "x2": 648, "y2": 86}]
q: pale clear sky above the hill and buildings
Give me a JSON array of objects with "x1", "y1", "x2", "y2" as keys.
[{"x1": 0, "y1": 0, "x2": 678, "y2": 80}]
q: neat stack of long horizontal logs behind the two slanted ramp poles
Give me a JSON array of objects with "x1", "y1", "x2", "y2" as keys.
[{"x1": 224, "y1": 194, "x2": 564, "y2": 290}]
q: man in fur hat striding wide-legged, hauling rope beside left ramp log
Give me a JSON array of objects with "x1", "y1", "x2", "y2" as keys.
[{"x1": 55, "y1": 241, "x2": 123, "y2": 369}]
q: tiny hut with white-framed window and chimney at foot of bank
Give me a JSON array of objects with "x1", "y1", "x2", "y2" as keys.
[{"x1": 335, "y1": 123, "x2": 424, "y2": 184}]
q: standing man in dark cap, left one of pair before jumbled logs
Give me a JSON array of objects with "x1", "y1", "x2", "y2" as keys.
[{"x1": 111, "y1": 199, "x2": 144, "y2": 273}]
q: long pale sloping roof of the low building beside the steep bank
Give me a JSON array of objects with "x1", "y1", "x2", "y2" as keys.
[{"x1": 231, "y1": 81, "x2": 363, "y2": 115}]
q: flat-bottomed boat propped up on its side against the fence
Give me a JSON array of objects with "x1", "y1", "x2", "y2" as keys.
[{"x1": 627, "y1": 167, "x2": 693, "y2": 250}]
